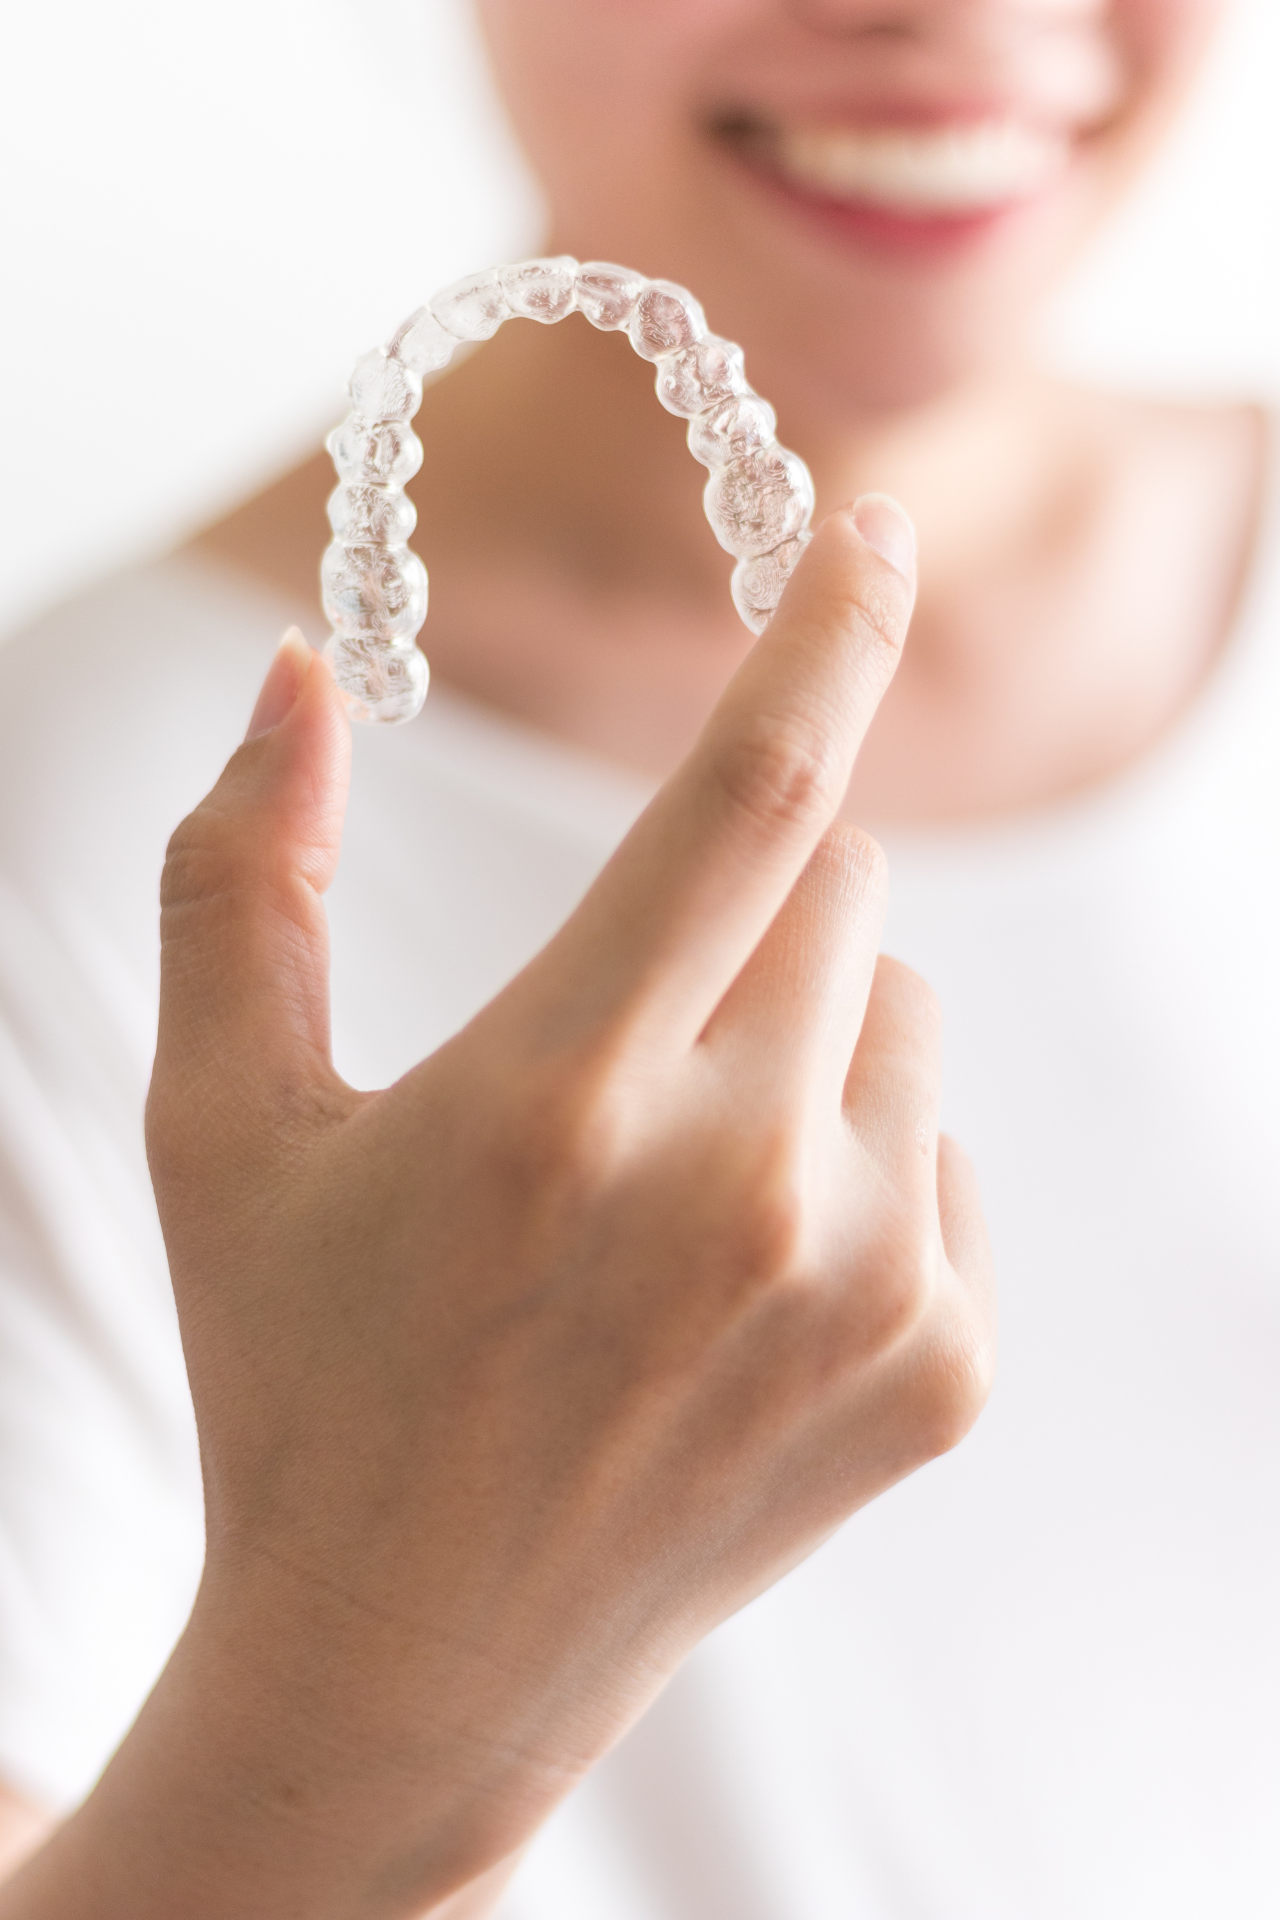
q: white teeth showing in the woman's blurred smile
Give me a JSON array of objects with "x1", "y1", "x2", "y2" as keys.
[{"x1": 768, "y1": 121, "x2": 1069, "y2": 213}]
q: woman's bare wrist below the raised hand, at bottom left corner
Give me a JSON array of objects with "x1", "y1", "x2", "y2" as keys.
[{"x1": 0, "y1": 1592, "x2": 528, "y2": 1920}]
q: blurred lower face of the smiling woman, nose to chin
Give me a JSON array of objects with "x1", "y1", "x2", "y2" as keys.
[{"x1": 480, "y1": 0, "x2": 1224, "y2": 426}]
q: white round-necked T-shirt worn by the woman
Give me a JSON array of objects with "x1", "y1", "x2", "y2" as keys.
[{"x1": 0, "y1": 460, "x2": 1280, "y2": 1920}]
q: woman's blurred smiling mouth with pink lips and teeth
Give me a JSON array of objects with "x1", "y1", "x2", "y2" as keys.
[{"x1": 725, "y1": 117, "x2": 1073, "y2": 244}]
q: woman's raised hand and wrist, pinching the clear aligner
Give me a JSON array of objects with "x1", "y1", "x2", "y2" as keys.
[{"x1": 2, "y1": 503, "x2": 992, "y2": 1920}]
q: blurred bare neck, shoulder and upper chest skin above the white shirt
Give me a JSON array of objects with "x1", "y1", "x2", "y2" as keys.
[{"x1": 196, "y1": 319, "x2": 1265, "y2": 826}]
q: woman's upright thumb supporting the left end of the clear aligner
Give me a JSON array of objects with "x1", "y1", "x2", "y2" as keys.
[{"x1": 148, "y1": 628, "x2": 351, "y2": 1162}]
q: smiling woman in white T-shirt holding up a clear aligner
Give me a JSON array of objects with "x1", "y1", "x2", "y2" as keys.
[{"x1": 0, "y1": 0, "x2": 1280, "y2": 1920}]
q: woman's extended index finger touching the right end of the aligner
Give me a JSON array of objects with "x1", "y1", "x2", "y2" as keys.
[{"x1": 537, "y1": 493, "x2": 915, "y2": 1044}]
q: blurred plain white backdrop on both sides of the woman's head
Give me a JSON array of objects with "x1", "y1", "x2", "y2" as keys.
[{"x1": 0, "y1": 0, "x2": 1280, "y2": 632}]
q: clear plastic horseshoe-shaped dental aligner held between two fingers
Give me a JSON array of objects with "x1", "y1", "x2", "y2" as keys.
[{"x1": 320, "y1": 255, "x2": 814, "y2": 722}]
